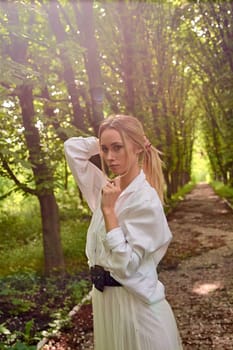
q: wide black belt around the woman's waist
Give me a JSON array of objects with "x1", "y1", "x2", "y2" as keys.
[{"x1": 91, "y1": 265, "x2": 121, "y2": 292}]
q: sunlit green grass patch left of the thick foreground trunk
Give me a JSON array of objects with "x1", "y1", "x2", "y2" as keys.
[{"x1": 0, "y1": 192, "x2": 43, "y2": 275}]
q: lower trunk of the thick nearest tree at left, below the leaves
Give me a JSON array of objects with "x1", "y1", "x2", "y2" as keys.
[{"x1": 18, "y1": 86, "x2": 65, "y2": 275}]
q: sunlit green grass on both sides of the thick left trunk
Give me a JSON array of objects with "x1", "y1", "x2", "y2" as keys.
[{"x1": 0, "y1": 189, "x2": 89, "y2": 276}]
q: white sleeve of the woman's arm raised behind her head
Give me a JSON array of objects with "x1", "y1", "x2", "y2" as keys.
[{"x1": 64, "y1": 136, "x2": 105, "y2": 211}]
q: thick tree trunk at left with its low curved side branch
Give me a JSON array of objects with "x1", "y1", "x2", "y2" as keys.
[{"x1": 1, "y1": 2, "x2": 65, "y2": 274}]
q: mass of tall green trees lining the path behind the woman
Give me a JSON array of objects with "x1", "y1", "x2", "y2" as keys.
[{"x1": 0, "y1": 0, "x2": 233, "y2": 274}]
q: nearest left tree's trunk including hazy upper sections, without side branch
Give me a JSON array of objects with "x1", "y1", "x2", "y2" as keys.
[{"x1": 6, "y1": 4, "x2": 64, "y2": 274}]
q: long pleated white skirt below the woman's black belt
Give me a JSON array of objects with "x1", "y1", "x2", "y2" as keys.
[{"x1": 92, "y1": 287, "x2": 182, "y2": 350}]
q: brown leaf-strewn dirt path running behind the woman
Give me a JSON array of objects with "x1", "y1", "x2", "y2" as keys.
[{"x1": 44, "y1": 184, "x2": 233, "y2": 350}]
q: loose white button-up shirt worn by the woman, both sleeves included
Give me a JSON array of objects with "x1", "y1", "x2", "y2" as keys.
[{"x1": 65, "y1": 137, "x2": 172, "y2": 304}]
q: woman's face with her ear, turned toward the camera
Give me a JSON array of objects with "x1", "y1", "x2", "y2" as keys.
[{"x1": 100, "y1": 129, "x2": 139, "y2": 176}]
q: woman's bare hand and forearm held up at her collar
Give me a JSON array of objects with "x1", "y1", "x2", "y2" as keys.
[{"x1": 101, "y1": 178, "x2": 121, "y2": 232}]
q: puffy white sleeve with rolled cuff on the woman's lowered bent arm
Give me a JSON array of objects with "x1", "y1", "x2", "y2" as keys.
[{"x1": 103, "y1": 201, "x2": 172, "y2": 279}]
